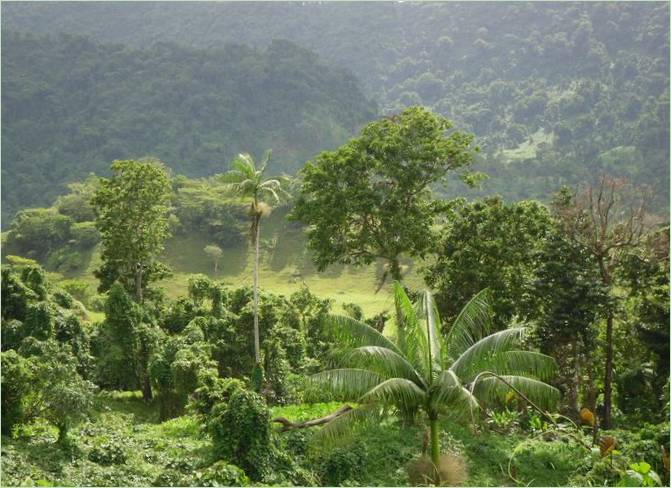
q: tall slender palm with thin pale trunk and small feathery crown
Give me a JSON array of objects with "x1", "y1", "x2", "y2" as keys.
[{"x1": 221, "y1": 151, "x2": 288, "y2": 365}]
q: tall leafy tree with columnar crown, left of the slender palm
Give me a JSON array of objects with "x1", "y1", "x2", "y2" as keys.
[{"x1": 92, "y1": 160, "x2": 171, "y2": 303}]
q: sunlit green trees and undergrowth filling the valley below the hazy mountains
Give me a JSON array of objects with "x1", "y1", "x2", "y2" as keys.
[{"x1": 2, "y1": 107, "x2": 669, "y2": 486}]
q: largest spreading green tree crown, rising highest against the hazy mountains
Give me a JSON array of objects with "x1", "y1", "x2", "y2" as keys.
[{"x1": 291, "y1": 107, "x2": 473, "y2": 283}]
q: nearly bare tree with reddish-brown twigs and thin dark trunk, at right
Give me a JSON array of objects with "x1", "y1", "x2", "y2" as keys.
[{"x1": 554, "y1": 175, "x2": 647, "y2": 429}]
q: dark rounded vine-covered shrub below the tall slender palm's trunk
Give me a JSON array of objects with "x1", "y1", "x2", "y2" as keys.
[{"x1": 207, "y1": 390, "x2": 271, "y2": 481}]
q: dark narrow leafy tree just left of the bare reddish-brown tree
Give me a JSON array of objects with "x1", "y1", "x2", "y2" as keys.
[{"x1": 520, "y1": 225, "x2": 607, "y2": 416}]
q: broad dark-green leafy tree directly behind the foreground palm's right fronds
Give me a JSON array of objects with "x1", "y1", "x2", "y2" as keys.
[{"x1": 424, "y1": 197, "x2": 551, "y2": 329}]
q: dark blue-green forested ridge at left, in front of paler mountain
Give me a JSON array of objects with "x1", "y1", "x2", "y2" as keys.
[{"x1": 2, "y1": 31, "x2": 377, "y2": 224}]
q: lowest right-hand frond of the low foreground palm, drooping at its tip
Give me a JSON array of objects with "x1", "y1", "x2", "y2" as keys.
[{"x1": 472, "y1": 375, "x2": 560, "y2": 410}]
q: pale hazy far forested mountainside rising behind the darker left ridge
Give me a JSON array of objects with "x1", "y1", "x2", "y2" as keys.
[{"x1": 2, "y1": 2, "x2": 669, "y2": 212}]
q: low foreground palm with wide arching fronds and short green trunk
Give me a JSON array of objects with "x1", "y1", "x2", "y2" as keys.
[{"x1": 312, "y1": 282, "x2": 559, "y2": 482}]
